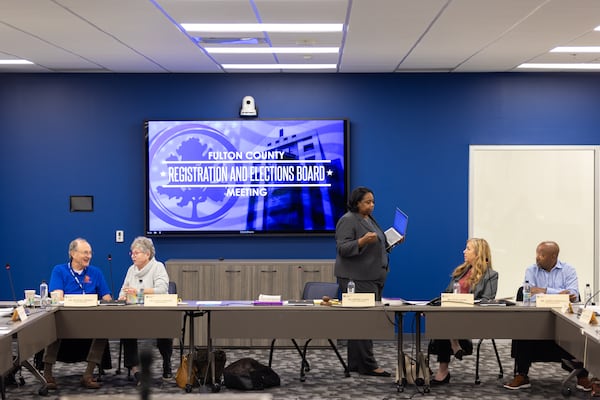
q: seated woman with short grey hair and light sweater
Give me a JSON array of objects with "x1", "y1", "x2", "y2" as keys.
[{"x1": 119, "y1": 236, "x2": 173, "y2": 385}]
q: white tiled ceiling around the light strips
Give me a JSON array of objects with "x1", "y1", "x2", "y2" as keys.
[{"x1": 0, "y1": 0, "x2": 600, "y2": 73}]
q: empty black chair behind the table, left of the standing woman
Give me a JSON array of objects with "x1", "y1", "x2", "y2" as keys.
[{"x1": 269, "y1": 282, "x2": 350, "y2": 382}]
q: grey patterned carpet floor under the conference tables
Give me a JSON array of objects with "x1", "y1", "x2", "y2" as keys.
[{"x1": 7, "y1": 340, "x2": 590, "y2": 400}]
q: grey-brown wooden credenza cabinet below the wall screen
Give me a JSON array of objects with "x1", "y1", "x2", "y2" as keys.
[{"x1": 165, "y1": 259, "x2": 336, "y2": 347}]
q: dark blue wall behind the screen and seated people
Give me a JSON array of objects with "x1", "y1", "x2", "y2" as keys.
[{"x1": 0, "y1": 73, "x2": 600, "y2": 299}]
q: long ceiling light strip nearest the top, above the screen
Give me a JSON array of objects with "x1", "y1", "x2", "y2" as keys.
[{"x1": 181, "y1": 24, "x2": 344, "y2": 32}]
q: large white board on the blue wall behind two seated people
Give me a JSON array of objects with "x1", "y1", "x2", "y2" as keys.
[{"x1": 469, "y1": 146, "x2": 600, "y2": 297}]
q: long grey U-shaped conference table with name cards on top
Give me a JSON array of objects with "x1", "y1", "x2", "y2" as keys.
[{"x1": 0, "y1": 301, "x2": 600, "y2": 391}]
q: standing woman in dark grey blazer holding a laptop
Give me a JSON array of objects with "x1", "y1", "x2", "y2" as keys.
[{"x1": 335, "y1": 187, "x2": 390, "y2": 377}]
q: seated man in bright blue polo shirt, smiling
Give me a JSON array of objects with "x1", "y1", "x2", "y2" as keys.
[{"x1": 44, "y1": 238, "x2": 112, "y2": 390}]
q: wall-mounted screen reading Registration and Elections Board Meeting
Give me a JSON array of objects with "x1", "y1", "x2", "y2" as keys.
[{"x1": 145, "y1": 119, "x2": 349, "y2": 237}]
